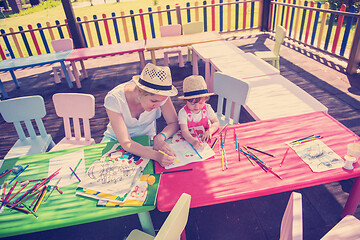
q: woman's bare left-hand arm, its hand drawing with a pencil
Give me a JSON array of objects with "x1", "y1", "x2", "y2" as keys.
[{"x1": 106, "y1": 109, "x2": 174, "y2": 167}]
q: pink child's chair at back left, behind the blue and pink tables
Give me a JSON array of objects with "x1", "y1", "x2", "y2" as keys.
[{"x1": 51, "y1": 38, "x2": 77, "y2": 83}]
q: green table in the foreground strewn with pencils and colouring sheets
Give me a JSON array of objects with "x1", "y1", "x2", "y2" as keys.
[{"x1": 0, "y1": 136, "x2": 155, "y2": 238}]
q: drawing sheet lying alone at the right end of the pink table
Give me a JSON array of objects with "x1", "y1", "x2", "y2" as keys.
[{"x1": 287, "y1": 139, "x2": 345, "y2": 172}]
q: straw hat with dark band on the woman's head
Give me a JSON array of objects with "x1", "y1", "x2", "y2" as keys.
[{"x1": 132, "y1": 63, "x2": 178, "y2": 96}]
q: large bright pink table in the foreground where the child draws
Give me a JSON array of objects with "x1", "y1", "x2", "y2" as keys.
[{"x1": 155, "y1": 112, "x2": 360, "y2": 216}]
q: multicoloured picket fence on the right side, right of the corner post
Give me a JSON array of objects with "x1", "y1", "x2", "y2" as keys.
[{"x1": 269, "y1": 0, "x2": 359, "y2": 60}]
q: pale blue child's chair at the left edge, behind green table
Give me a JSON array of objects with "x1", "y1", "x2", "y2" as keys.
[{"x1": 0, "y1": 96, "x2": 55, "y2": 159}]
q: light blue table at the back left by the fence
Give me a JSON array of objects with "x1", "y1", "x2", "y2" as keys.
[{"x1": 0, "y1": 50, "x2": 73, "y2": 98}]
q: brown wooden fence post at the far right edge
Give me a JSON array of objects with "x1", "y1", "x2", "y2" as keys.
[{"x1": 346, "y1": 19, "x2": 360, "y2": 74}]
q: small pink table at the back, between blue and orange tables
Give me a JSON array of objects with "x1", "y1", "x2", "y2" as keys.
[{"x1": 65, "y1": 40, "x2": 145, "y2": 88}]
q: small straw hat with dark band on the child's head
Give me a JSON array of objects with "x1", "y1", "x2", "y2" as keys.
[{"x1": 179, "y1": 75, "x2": 214, "y2": 99}]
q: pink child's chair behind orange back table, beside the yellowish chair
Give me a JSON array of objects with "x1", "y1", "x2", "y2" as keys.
[{"x1": 160, "y1": 24, "x2": 185, "y2": 67}]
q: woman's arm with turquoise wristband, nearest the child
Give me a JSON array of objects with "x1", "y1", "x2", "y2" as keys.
[{"x1": 153, "y1": 98, "x2": 179, "y2": 156}]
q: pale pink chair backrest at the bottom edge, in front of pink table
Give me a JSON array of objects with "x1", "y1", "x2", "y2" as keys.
[{"x1": 280, "y1": 192, "x2": 303, "y2": 240}]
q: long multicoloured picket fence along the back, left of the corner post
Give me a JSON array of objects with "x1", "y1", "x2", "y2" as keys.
[{"x1": 0, "y1": 0, "x2": 261, "y2": 60}]
